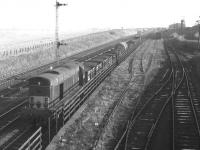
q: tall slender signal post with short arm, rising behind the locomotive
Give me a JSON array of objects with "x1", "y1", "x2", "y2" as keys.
[{"x1": 55, "y1": 0, "x2": 67, "y2": 64}]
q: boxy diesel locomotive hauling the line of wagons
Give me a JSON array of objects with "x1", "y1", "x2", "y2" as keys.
[{"x1": 29, "y1": 62, "x2": 83, "y2": 111}]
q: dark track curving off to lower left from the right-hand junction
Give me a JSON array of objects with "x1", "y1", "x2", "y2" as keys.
[{"x1": 122, "y1": 69, "x2": 173, "y2": 149}]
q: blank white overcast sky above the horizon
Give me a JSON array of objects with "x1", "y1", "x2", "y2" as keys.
[{"x1": 0, "y1": 0, "x2": 200, "y2": 32}]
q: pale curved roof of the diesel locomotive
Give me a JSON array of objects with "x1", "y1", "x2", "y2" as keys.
[{"x1": 29, "y1": 61, "x2": 79, "y2": 86}]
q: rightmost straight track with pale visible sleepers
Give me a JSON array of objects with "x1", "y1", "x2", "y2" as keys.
[{"x1": 172, "y1": 52, "x2": 200, "y2": 150}]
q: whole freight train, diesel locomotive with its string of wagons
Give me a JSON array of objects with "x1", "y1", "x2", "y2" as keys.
[{"x1": 28, "y1": 41, "x2": 134, "y2": 118}]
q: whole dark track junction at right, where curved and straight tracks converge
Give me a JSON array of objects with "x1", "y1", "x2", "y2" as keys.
[{"x1": 114, "y1": 39, "x2": 200, "y2": 150}]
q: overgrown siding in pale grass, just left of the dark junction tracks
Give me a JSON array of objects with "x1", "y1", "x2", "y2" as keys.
[{"x1": 95, "y1": 40, "x2": 165, "y2": 150}]
